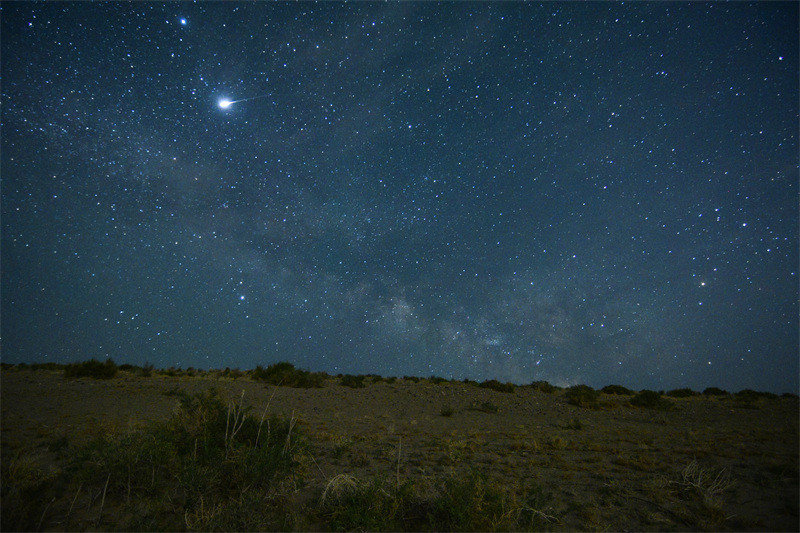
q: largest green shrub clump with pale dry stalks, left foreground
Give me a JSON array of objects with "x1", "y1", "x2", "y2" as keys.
[{"x1": 2, "y1": 392, "x2": 302, "y2": 531}]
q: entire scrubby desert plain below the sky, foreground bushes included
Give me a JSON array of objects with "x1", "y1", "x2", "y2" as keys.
[{"x1": 0, "y1": 361, "x2": 798, "y2": 531}]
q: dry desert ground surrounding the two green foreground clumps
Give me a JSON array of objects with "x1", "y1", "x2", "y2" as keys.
[{"x1": 0, "y1": 367, "x2": 798, "y2": 531}]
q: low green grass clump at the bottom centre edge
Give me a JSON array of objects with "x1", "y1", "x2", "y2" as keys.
[{"x1": 316, "y1": 473, "x2": 555, "y2": 531}]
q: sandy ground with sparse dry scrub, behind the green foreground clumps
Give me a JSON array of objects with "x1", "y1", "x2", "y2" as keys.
[{"x1": 0, "y1": 370, "x2": 799, "y2": 531}]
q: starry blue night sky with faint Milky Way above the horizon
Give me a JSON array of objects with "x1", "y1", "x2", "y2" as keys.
[{"x1": 1, "y1": 2, "x2": 798, "y2": 392}]
